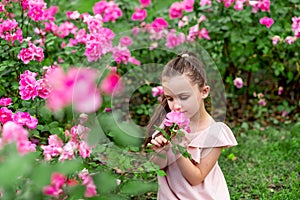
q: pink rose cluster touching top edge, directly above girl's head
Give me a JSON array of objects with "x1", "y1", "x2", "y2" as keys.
[{"x1": 169, "y1": 0, "x2": 194, "y2": 19}]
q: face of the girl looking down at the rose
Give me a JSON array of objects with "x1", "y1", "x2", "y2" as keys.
[{"x1": 162, "y1": 75, "x2": 209, "y2": 120}]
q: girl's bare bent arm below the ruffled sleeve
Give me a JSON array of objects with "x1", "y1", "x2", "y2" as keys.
[{"x1": 177, "y1": 147, "x2": 222, "y2": 186}]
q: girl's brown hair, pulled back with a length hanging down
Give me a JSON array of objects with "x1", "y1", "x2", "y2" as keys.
[{"x1": 144, "y1": 51, "x2": 207, "y2": 148}]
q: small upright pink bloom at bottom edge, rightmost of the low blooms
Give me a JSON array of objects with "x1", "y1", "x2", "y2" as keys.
[{"x1": 78, "y1": 169, "x2": 97, "y2": 198}]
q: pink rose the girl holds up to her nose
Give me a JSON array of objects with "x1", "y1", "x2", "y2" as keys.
[{"x1": 164, "y1": 111, "x2": 191, "y2": 133}]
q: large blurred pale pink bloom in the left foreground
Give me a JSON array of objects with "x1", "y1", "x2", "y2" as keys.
[{"x1": 46, "y1": 67, "x2": 102, "y2": 113}]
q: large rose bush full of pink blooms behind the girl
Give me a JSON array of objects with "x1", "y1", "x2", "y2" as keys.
[{"x1": 0, "y1": 0, "x2": 300, "y2": 199}]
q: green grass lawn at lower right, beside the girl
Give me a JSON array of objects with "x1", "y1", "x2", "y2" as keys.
[{"x1": 219, "y1": 123, "x2": 300, "y2": 200}]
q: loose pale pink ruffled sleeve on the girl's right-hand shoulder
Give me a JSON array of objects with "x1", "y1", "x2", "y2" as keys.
[{"x1": 187, "y1": 122, "x2": 237, "y2": 163}]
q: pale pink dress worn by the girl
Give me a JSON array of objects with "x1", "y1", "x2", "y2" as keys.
[{"x1": 154, "y1": 122, "x2": 237, "y2": 200}]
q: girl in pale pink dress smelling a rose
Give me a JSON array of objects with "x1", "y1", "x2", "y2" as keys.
[{"x1": 145, "y1": 52, "x2": 237, "y2": 200}]
